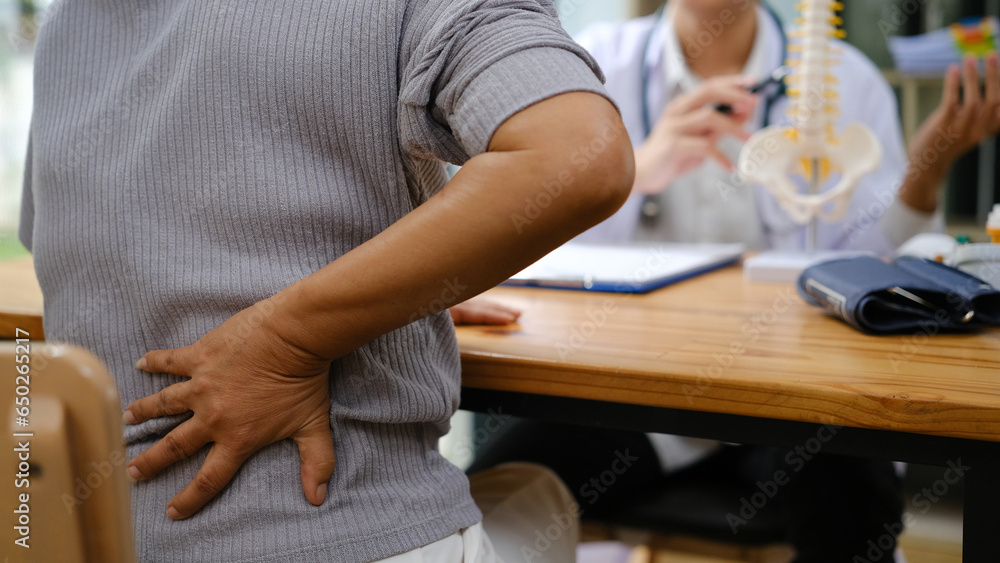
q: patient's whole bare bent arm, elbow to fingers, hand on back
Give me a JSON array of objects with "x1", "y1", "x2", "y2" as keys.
[{"x1": 125, "y1": 93, "x2": 633, "y2": 519}]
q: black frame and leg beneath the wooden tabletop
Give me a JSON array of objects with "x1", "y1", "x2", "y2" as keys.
[{"x1": 461, "y1": 388, "x2": 1000, "y2": 563}]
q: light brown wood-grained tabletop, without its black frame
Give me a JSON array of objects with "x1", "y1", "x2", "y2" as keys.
[{"x1": 0, "y1": 259, "x2": 1000, "y2": 441}]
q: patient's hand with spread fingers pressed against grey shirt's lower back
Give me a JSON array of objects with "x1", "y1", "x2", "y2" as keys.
[{"x1": 124, "y1": 298, "x2": 335, "y2": 520}]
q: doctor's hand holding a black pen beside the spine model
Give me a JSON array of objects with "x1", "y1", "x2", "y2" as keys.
[{"x1": 633, "y1": 76, "x2": 757, "y2": 194}]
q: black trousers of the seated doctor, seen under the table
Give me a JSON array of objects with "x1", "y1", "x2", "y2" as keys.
[{"x1": 469, "y1": 419, "x2": 903, "y2": 563}]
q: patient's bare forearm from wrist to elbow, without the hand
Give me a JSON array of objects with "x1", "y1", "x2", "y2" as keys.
[{"x1": 273, "y1": 93, "x2": 632, "y2": 358}]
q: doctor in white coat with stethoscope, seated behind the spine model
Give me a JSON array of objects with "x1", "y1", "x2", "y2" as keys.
[{"x1": 577, "y1": 0, "x2": 1000, "y2": 255}]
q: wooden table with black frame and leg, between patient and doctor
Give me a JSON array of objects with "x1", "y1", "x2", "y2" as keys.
[{"x1": 458, "y1": 268, "x2": 1000, "y2": 563}]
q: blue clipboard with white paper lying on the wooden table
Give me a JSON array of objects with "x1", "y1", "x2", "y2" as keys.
[{"x1": 504, "y1": 243, "x2": 745, "y2": 293}]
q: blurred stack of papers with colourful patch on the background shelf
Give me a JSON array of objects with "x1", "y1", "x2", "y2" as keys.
[{"x1": 889, "y1": 18, "x2": 1000, "y2": 74}]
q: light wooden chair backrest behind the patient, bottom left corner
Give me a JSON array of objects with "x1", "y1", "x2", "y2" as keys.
[{"x1": 0, "y1": 342, "x2": 135, "y2": 563}]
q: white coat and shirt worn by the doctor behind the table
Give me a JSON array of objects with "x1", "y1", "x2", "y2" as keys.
[{"x1": 577, "y1": 6, "x2": 944, "y2": 471}]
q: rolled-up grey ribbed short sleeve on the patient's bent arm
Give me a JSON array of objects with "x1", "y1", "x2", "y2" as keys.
[{"x1": 399, "y1": 0, "x2": 610, "y2": 164}]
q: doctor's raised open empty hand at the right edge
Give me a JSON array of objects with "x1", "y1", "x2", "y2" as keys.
[{"x1": 899, "y1": 53, "x2": 1000, "y2": 212}]
